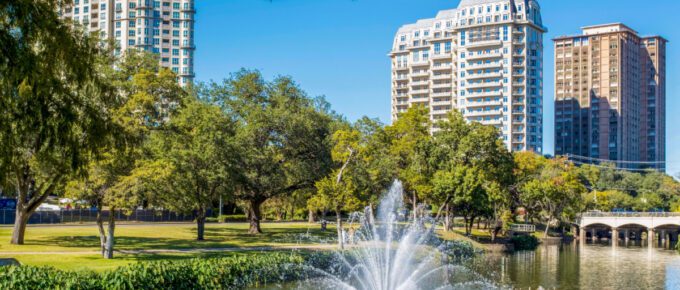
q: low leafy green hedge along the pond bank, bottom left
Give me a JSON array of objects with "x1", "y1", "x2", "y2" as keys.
[{"x1": 0, "y1": 253, "x2": 320, "y2": 289}]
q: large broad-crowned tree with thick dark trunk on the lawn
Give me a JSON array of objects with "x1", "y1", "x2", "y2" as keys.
[{"x1": 202, "y1": 70, "x2": 332, "y2": 234}]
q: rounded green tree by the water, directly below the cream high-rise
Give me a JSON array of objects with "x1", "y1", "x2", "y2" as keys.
[{"x1": 429, "y1": 111, "x2": 514, "y2": 238}]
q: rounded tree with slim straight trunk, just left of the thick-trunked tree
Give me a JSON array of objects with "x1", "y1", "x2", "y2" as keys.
[{"x1": 140, "y1": 99, "x2": 237, "y2": 241}]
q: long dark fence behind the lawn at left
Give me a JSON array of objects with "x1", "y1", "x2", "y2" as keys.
[{"x1": 0, "y1": 209, "x2": 212, "y2": 225}]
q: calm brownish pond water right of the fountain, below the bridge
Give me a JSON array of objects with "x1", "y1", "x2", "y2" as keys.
[{"x1": 488, "y1": 243, "x2": 680, "y2": 289}]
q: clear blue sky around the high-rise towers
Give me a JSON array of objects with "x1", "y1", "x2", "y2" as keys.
[{"x1": 195, "y1": 0, "x2": 680, "y2": 175}]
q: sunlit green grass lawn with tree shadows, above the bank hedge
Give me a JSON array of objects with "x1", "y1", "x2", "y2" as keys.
[{"x1": 0, "y1": 223, "x2": 335, "y2": 271}]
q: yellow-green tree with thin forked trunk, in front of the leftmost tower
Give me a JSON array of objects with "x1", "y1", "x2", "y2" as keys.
[{"x1": 66, "y1": 50, "x2": 185, "y2": 259}]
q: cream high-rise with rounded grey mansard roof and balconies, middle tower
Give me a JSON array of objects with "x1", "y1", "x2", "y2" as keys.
[{"x1": 390, "y1": 0, "x2": 546, "y2": 153}]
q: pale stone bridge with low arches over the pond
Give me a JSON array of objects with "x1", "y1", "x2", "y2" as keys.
[{"x1": 576, "y1": 212, "x2": 680, "y2": 247}]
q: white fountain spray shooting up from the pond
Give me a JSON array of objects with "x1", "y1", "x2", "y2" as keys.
[{"x1": 284, "y1": 181, "x2": 498, "y2": 290}]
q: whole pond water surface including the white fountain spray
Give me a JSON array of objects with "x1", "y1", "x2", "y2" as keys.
[{"x1": 251, "y1": 181, "x2": 680, "y2": 290}]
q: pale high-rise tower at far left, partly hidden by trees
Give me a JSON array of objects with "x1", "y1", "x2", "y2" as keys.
[{"x1": 60, "y1": 0, "x2": 196, "y2": 85}]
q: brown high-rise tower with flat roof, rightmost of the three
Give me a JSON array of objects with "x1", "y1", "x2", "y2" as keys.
[{"x1": 554, "y1": 24, "x2": 667, "y2": 170}]
